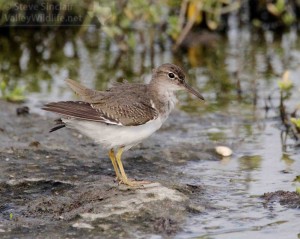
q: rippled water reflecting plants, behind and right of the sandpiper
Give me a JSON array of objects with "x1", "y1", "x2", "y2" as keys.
[{"x1": 0, "y1": 24, "x2": 300, "y2": 238}]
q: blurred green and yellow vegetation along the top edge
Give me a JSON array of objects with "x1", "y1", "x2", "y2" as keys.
[{"x1": 0, "y1": 0, "x2": 300, "y2": 37}]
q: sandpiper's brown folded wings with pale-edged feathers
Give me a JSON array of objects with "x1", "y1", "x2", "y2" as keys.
[{"x1": 43, "y1": 80, "x2": 158, "y2": 126}]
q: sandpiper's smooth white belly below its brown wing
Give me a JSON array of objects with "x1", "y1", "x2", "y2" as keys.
[{"x1": 62, "y1": 117, "x2": 164, "y2": 150}]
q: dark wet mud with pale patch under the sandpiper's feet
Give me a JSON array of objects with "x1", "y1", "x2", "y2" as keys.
[{"x1": 0, "y1": 102, "x2": 205, "y2": 238}]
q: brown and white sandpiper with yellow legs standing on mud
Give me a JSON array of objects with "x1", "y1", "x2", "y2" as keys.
[{"x1": 43, "y1": 63, "x2": 204, "y2": 186}]
